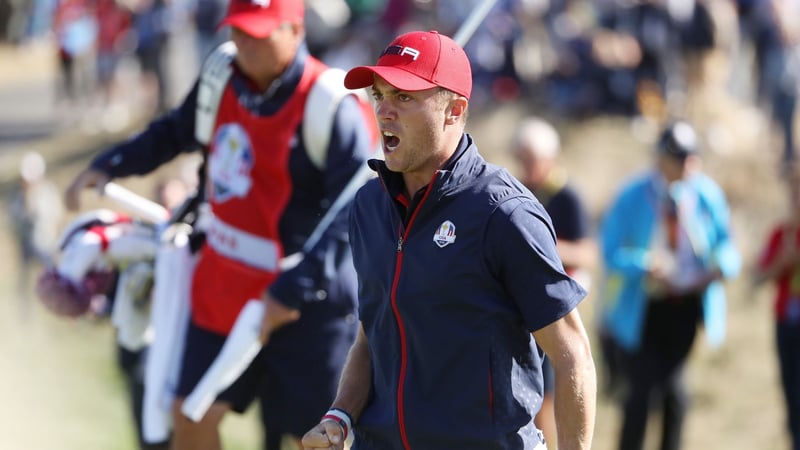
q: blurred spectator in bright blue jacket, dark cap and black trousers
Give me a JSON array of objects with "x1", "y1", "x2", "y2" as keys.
[{"x1": 601, "y1": 121, "x2": 741, "y2": 450}]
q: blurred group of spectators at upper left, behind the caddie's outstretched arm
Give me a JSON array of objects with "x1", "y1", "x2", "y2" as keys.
[{"x1": 0, "y1": 0, "x2": 227, "y2": 121}]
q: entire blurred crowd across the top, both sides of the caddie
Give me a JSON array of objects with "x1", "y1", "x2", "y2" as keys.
[{"x1": 0, "y1": 0, "x2": 800, "y2": 160}]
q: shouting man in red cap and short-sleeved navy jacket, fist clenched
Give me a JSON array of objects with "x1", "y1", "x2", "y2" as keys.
[{"x1": 303, "y1": 32, "x2": 596, "y2": 450}]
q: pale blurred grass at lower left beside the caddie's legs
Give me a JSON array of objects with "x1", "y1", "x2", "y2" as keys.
[{"x1": 0, "y1": 230, "x2": 260, "y2": 450}]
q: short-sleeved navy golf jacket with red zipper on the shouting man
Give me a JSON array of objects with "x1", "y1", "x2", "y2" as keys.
[{"x1": 350, "y1": 134, "x2": 586, "y2": 450}]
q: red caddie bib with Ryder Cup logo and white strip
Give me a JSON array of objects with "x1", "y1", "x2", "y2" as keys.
[{"x1": 192, "y1": 57, "x2": 325, "y2": 334}]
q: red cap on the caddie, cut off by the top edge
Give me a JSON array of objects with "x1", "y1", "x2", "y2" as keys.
[{"x1": 219, "y1": 0, "x2": 305, "y2": 38}]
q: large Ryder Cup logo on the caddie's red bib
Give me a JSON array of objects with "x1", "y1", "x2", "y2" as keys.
[{"x1": 208, "y1": 123, "x2": 254, "y2": 202}]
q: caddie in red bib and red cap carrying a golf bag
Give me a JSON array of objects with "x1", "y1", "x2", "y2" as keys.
[{"x1": 65, "y1": 0, "x2": 376, "y2": 450}]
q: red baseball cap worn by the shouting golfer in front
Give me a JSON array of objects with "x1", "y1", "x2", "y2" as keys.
[{"x1": 344, "y1": 31, "x2": 472, "y2": 99}]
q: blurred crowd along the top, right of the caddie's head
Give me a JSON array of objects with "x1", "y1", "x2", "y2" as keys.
[{"x1": 300, "y1": 0, "x2": 800, "y2": 164}]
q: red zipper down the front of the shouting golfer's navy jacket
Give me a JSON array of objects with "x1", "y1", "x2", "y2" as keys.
[{"x1": 390, "y1": 172, "x2": 438, "y2": 450}]
